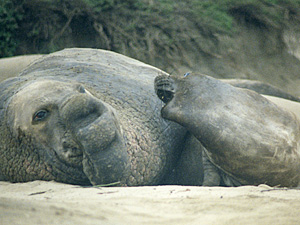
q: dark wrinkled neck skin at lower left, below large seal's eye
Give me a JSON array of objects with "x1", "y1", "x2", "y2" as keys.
[{"x1": 0, "y1": 125, "x2": 91, "y2": 185}]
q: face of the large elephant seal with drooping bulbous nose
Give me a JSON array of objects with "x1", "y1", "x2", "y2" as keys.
[{"x1": 2, "y1": 79, "x2": 128, "y2": 184}]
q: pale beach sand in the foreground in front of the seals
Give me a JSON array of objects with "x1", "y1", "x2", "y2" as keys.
[{"x1": 0, "y1": 181, "x2": 300, "y2": 225}]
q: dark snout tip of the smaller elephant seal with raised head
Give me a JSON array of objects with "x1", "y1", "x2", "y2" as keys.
[{"x1": 154, "y1": 75, "x2": 175, "y2": 103}]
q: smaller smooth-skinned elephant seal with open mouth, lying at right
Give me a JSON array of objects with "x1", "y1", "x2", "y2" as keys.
[{"x1": 155, "y1": 74, "x2": 300, "y2": 187}]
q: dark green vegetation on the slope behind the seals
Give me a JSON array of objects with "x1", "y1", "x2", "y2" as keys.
[{"x1": 0, "y1": 0, "x2": 300, "y2": 63}]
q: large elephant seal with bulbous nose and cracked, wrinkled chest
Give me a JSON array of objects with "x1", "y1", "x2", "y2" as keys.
[{"x1": 0, "y1": 49, "x2": 186, "y2": 185}]
